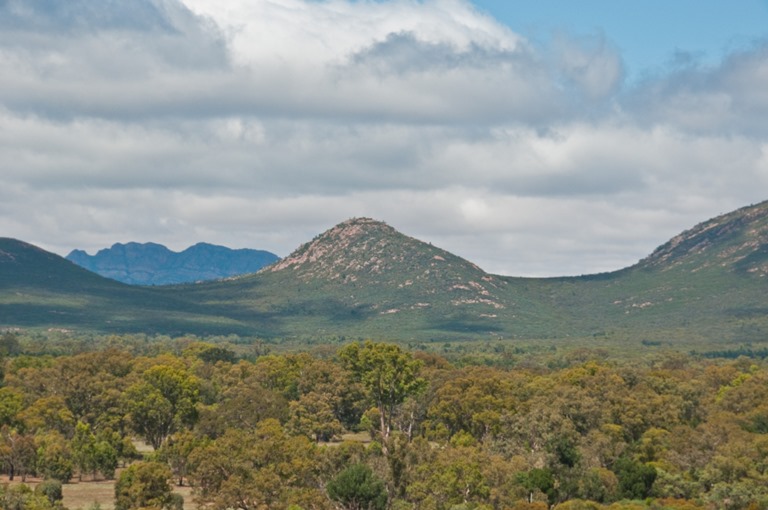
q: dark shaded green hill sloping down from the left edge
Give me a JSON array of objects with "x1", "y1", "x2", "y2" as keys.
[{"x1": 0, "y1": 238, "x2": 247, "y2": 334}]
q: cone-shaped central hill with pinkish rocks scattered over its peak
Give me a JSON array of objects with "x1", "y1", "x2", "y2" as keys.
[{"x1": 179, "y1": 218, "x2": 560, "y2": 338}]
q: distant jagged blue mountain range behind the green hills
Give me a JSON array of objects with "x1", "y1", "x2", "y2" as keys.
[{"x1": 66, "y1": 243, "x2": 278, "y2": 285}]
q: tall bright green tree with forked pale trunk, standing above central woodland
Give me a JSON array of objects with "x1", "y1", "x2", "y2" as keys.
[{"x1": 339, "y1": 341, "x2": 426, "y2": 444}]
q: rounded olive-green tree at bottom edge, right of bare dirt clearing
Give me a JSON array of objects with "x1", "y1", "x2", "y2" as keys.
[{"x1": 115, "y1": 462, "x2": 178, "y2": 510}]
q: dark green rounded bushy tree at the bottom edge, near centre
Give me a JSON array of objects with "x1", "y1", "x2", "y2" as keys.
[{"x1": 326, "y1": 464, "x2": 387, "y2": 510}]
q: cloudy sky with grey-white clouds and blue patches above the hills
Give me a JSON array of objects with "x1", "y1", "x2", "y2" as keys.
[{"x1": 0, "y1": 0, "x2": 768, "y2": 276}]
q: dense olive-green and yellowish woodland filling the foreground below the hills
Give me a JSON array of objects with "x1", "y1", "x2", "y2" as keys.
[{"x1": 0, "y1": 332, "x2": 768, "y2": 510}]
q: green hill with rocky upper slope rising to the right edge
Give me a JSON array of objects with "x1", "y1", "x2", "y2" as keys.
[{"x1": 516, "y1": 202, "x2": 768, "y2": 342}]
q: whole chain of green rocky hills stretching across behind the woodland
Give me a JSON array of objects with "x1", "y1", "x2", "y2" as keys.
[{"x1": 0, "y1": 202, "x2": 768, "y2": 349}]
